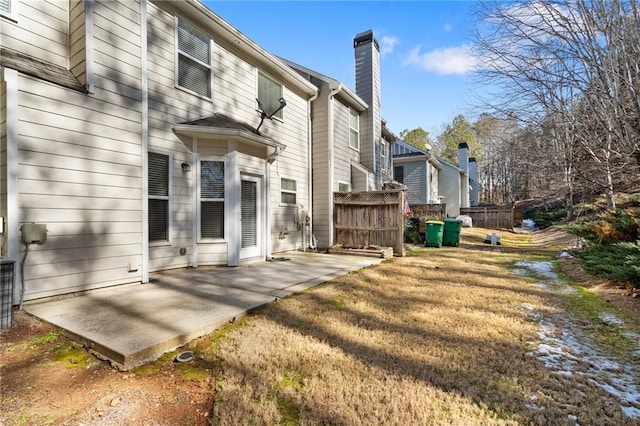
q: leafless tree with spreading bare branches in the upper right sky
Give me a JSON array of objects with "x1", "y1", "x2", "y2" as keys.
[{"x1": 476, "y1": 0, "x2": 640, "y2": 212}]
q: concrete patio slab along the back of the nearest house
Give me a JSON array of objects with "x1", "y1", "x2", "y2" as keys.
[{"x1": 24, "y1": 252, "x2": 383, "y2": 369}]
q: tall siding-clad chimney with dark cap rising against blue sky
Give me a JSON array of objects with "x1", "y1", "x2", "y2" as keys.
[{"x1": 353, "y1": 30, "x2": 382, "y2": 189}]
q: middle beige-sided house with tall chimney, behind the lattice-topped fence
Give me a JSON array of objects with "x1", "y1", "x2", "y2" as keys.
[{"x1": 286, "y1": 31, "x2": 396, "y2": 248}]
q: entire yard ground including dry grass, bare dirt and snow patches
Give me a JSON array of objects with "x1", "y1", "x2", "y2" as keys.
[{"x1": 0, "y1": 228, "x2": 640, "y2": 426}]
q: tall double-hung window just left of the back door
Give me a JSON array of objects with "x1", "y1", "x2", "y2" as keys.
[{"x1": 200, "y1": 161, "x2": 224, "y2": 240}]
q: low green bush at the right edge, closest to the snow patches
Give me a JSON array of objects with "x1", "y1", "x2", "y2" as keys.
[{"x1": 575, "y1": 241, "x2": 640, "y2": 288}]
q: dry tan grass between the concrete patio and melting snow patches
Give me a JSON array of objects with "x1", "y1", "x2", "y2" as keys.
[{"x1": 214, "y1": 230, "x2": 628, "y2": 425}]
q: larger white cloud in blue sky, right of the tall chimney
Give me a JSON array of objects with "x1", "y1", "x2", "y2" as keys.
[{"x1": 404, "y1": 44, "x2": 476, "y2": 75}]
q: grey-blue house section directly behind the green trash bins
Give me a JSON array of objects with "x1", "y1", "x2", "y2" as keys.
[{"x1": 393, "y1": 141, "x2": 442, "y2": 204}]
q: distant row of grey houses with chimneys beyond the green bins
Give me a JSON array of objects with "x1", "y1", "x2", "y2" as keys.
[{"x1": 393, "y1": 141, "x2": 480, "y2": 217}]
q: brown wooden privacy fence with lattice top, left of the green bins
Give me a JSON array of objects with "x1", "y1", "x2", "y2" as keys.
[{"x1": 333, "y1": 189, "x2": 405, "y2": 256}]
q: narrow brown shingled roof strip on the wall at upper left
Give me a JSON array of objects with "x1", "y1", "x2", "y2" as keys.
[{"x1": 0, "y1": 47, "x2": 87, "y2": 93}]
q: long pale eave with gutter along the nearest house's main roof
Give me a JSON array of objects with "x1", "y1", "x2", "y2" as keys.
[{"x1": 174, "y1": 0, "x2": 317, "y2": 97}]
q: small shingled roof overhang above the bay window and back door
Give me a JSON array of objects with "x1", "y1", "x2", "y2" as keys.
[{"x1": 173, "y1": 113, "x2": 286, "y2": 163}]
